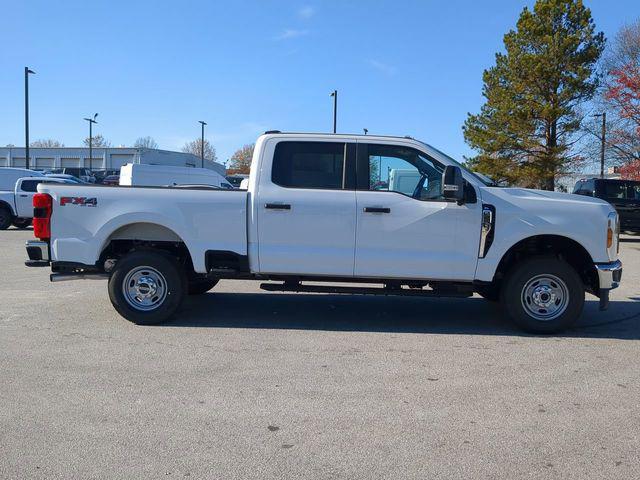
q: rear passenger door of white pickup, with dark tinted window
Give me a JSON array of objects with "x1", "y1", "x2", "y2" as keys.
[{"x1": 254, "y1": 140, "x2": 356, "y2": 276}]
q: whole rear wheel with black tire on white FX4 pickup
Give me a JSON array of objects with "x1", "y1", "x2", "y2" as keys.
[{"x1": 108, "y1": 251, "x2": 187, "y2": 325}]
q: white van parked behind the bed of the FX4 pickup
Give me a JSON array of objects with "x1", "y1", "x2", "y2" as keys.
[{"x1": 120, "y1": 163, "x2": 233, "y2": 189}]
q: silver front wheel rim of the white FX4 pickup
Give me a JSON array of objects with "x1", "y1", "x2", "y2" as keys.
[{"x1": 522, "y1": 274, "x2": 569, "y2": 321}]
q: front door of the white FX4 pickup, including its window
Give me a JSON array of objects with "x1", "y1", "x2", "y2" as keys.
[{"x1": 355, "y1": 143, "x2": 481, "y2": 280}]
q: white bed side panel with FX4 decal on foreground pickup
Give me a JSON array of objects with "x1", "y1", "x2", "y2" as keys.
[{"x1": 38, "y1": 185, "x2": 247, "y2": 273}]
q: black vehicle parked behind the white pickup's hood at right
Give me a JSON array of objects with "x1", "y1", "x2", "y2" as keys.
[{"x1": 573, "y1": 178, "x2": 640, "y2": 233}]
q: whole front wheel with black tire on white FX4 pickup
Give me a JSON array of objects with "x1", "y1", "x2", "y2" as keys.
[{"x1": 500, "y1": 256, "x2": 585, "y2": 334}]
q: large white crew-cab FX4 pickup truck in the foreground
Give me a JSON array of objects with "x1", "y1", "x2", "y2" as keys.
[{"x1": 26, "y1": 131, "x2": 622, "y2": 333}]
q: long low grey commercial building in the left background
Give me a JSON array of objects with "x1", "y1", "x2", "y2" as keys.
[{"x1": 0, "y1": 147, "x2": 225, "y2": 175}]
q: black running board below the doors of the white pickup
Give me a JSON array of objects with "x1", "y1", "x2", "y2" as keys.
[{"x1": 260, "y1": 282, "x2": 473, "y2": 298}]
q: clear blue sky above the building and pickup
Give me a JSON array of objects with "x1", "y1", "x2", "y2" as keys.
[{"x1": 0, "y1": 0, "x2": 640, "y2": 161}]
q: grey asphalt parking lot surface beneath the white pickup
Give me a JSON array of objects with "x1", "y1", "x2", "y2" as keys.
[{"x1": 0, "y1": 229, "x2": 640, "y2": 479}]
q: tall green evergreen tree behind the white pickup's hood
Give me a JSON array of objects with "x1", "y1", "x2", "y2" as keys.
[{"x1": 463, "y1": 0, "x2": 605, "y2": 190}]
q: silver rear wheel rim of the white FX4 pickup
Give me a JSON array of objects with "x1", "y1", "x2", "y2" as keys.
[{"x1": 122, "y1": 266, "x2": 167, "y2": 312}]
